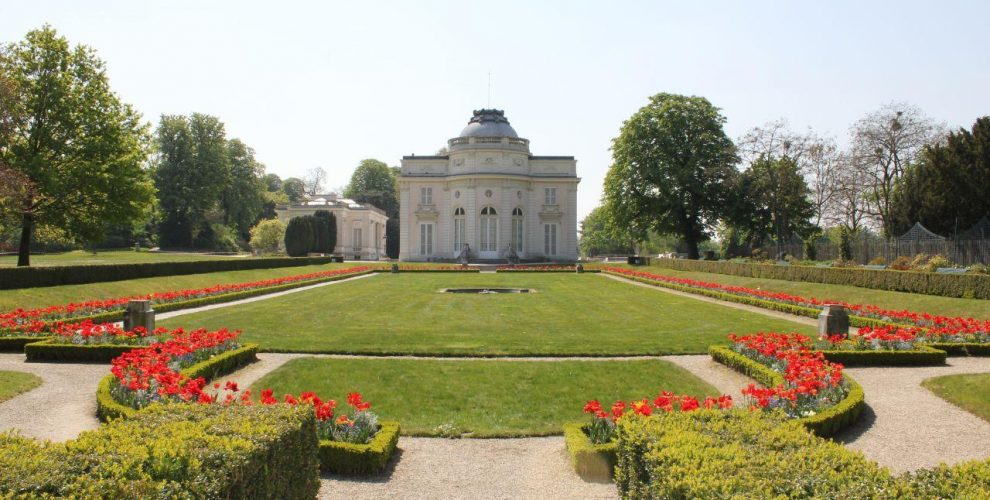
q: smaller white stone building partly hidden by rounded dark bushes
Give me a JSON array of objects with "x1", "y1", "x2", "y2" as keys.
[{"x1": 275, "y1": 194, "x2": 388, "y2": 260}]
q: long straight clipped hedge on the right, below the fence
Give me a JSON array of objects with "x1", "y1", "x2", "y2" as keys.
[{"x1": 652, "y1": 259, "x2": 990, "y2": 299}]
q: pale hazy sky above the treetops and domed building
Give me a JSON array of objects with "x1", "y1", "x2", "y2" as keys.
[{"x1": 0, "y1": 0, "x2": 990, "y2": 220}]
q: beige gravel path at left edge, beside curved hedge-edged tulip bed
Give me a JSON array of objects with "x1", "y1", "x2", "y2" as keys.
[{"x1": 0, "y1": 353, "x2": 103, "y2": 441}]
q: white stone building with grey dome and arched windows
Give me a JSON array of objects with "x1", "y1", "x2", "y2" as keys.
[{"x1": 399, "y1": 109, "x2": 581, "y2": 261}]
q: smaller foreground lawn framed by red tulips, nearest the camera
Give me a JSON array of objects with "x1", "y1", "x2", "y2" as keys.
[{"x1": 252, "y1": 358, "x2": 717, "y2": 437}]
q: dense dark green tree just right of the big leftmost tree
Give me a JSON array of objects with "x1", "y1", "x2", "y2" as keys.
[{"x1": 155, "y1": 113, "x2": 230, "y2": 247}]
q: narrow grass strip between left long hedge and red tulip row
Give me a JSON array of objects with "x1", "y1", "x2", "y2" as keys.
[{"x1": 0, "y1": 262, "x2": 360, "y2": 311}]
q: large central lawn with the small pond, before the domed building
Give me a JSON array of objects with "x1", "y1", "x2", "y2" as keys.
[{"x1": 160, "y1": 273, "x2": 814, "y2": 356}]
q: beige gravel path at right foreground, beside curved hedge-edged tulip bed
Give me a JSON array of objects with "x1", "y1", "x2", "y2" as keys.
[{"x1": 837, "y1": 357, "x2": 990, "y2": 472}]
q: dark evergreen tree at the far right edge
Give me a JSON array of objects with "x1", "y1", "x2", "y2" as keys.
[{"x1": 892, "y1": 116, "x2": 990, "y2": 235}]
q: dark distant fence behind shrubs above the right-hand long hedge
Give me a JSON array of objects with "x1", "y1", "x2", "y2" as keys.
[{"x1": 762, "y1": 238, "x2": 990, "y2": 266}]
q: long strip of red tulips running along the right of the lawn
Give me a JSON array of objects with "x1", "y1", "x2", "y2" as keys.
[{"x1": 604, "y1": 267, "x2": 990, "y2": 354}]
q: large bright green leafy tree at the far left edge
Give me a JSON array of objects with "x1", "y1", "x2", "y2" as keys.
[{"x1": 0, "y1": 26, "x2": 154, "y2": 266}]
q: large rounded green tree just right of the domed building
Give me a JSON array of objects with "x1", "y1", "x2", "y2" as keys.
[{"x1": 605, "y1": 93, "x2": 738, "y2": 259}]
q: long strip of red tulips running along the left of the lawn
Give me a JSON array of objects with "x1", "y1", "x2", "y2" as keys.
[{"x1": 0, "y1": 266, "x2": 372, "y2": 337}]
